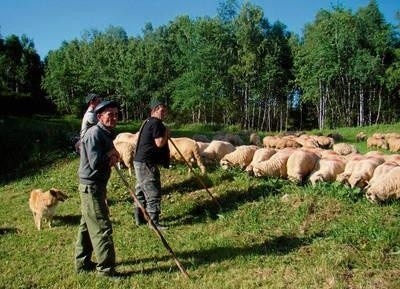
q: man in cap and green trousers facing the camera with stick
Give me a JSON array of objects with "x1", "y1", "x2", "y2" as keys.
[{"x1": 75, "y1": 101, "x2": 119, "y2": 277}]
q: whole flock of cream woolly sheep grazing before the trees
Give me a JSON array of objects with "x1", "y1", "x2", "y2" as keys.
[{"x1": 114, "y1": 132, "x2": 400, "y2": 203}]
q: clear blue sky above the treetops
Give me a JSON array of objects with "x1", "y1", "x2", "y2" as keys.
[{"x1": 0, "y1": 0, "x2": 400, "y2": 59}]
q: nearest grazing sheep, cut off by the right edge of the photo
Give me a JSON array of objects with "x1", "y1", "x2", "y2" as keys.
[{"x1": 365, "y1": 166, "x2": 400, "y2": 203}]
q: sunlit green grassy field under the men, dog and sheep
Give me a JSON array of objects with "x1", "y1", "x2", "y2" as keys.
[{"x1": 0, "y1": 116, "x2": 400, "y2": 289}]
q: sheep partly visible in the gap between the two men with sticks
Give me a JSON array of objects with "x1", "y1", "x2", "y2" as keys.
[{"x1": 113, "y1": 132, "x2": 138, "y2": 176}]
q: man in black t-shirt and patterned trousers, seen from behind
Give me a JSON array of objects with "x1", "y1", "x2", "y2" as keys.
[{"x1": 133, "y1": 100, "x2": 170, "y2": 230}]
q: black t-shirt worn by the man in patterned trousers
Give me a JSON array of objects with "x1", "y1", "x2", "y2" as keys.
[{"x1": 134, "y1": 117, "x2": 169, "y2": 166}]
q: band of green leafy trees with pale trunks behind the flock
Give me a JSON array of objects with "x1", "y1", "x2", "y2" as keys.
[{"x1": 0, "y1": 0, "x2": 400, "y2": 131}]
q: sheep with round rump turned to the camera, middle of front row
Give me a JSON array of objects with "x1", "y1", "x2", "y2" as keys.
[{"x1": 286, "y1": 149, "x2": 319, "y2": 183}]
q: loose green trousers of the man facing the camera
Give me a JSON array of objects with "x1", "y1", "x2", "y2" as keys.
[{"x1": 75, "y1": 184, "x2": 115, "y2": 272}]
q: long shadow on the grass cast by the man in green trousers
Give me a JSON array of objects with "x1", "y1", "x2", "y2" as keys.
[{"x1": 119, "y1": 234, "x2": 321, "y2": 274}]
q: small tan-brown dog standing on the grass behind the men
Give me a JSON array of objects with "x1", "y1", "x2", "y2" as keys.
[{"x1": 29, "y1": 188, "x2": 68, "y2": 230}]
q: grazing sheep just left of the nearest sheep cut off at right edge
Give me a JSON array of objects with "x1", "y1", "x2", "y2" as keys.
[{"x1": 349, "y1": 157, "x2": 384, "y2": 189}]
